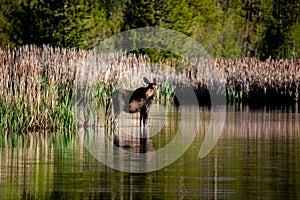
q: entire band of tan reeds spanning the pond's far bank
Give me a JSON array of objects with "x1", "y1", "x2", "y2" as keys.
[{"x1": 0, "y1": 45, "x2": 300, "y2": 132}]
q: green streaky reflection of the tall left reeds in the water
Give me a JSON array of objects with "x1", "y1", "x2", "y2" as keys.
[{"x1": 0, "y1": 133, "x2": 79, "y2": 199}]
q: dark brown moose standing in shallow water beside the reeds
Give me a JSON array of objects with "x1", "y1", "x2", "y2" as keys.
[{"x1": 112, "y1": 77, "x2": 158, "y2": 127}]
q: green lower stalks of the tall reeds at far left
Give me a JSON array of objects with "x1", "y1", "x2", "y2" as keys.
[{"x1": 0, "y1": 80, "x2": 75, "y2": 133}]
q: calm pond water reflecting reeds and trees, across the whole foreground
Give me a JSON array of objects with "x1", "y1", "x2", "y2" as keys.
[{"x1": 0, "y1": 104, "x2": 300, "y2": 199}]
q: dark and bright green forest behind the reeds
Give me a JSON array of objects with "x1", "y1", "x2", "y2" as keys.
[{"x1": 0, "y1": 0, "x2": 300, "y2": 60}]
